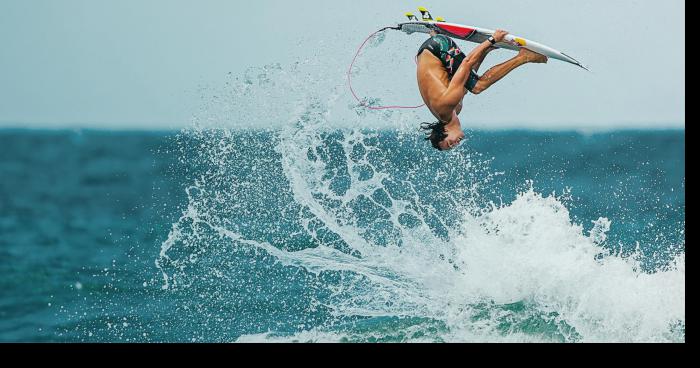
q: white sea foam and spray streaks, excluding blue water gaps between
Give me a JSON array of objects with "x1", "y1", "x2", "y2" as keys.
[{"x1": 156, "y1": 59, "x2": 685, "y2": 342}]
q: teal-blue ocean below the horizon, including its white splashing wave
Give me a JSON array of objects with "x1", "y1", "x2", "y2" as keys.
[{"x1": 0, "y1": 127, "x2": 685, "y2": 342}]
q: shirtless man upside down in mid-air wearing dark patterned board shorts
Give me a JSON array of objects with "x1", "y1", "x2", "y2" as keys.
[{"x1": 418, "y1": 30, "x2": 548, "y2": 151}]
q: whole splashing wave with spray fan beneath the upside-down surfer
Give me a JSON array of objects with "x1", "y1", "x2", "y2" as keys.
[{"x1": 156, "y1": 61, "x2": 685, "y2": 342}]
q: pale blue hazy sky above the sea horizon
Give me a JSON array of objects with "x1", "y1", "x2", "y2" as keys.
[{"x1": 0, "y1": 0, "x2": 685, "y2": 130}]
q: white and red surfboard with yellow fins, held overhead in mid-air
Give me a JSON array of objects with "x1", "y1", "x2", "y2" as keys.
[{"x1": 397, "y1": 7, "x2": 588, "y2": 70}]
